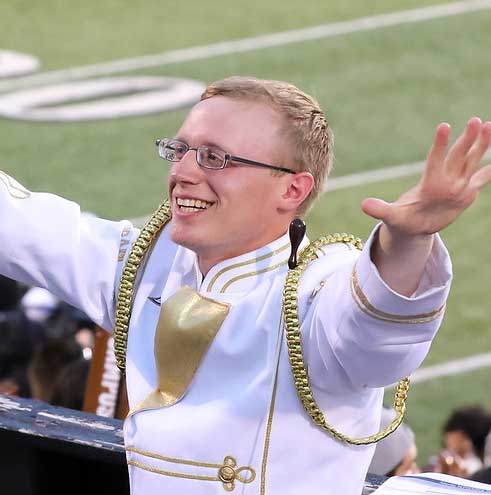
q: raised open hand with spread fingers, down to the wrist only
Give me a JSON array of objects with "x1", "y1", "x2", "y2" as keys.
[{"x1": 362, "y1": 117, "x2": 491, "y2": 237}]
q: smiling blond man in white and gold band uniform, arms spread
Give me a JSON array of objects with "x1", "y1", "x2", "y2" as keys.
[{"x1": 0, "y1": 77, "x2": 491, "y2": 495}]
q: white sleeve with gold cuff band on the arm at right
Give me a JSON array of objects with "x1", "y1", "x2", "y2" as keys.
[{"x1": 302, "y1": 225, "x2": 452, "y2": 389}]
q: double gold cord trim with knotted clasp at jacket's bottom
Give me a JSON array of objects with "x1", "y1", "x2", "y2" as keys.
[{"x1": 126, "y1": 446, "x2": 256, "y2": 492}]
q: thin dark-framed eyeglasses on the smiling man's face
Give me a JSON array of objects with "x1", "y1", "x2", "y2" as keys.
[{"x1": 155, "y1": 138, "x2": 296, "y2": 174}]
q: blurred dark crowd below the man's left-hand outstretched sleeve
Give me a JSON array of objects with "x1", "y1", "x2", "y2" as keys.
[{"x1": 0, "y1": 276, "x2": 95, "y2": 409}]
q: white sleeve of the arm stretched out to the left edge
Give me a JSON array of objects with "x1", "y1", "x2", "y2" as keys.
[{"x1": 0, "y1": 172, "x2": 138, "y2": 331}]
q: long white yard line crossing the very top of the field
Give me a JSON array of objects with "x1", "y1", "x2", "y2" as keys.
[{"x1": 0, "y1": 0, "x2": 491, "y2": 91}]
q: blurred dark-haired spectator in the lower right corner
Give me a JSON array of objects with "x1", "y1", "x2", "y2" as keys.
[{"x1": 427, "y1": 406, "x2": 491, "y2": 478}]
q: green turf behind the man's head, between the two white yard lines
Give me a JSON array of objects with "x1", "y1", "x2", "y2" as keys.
[{"x1": 0, "y1": 7, "x2": 491, "y2": 218}]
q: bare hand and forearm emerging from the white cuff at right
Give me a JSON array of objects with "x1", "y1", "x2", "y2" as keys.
[{"x1": 362, "y1": 117, "x2": 491, "y2": 296}]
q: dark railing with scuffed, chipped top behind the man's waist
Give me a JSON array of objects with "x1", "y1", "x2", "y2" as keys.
[{"x1": 0, "y1": 394, "x2": 384, "y2": 495}]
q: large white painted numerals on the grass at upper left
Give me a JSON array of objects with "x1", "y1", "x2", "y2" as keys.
[{"x1": 0, "y1": 51, "x2": 205, "y2": 122}]
